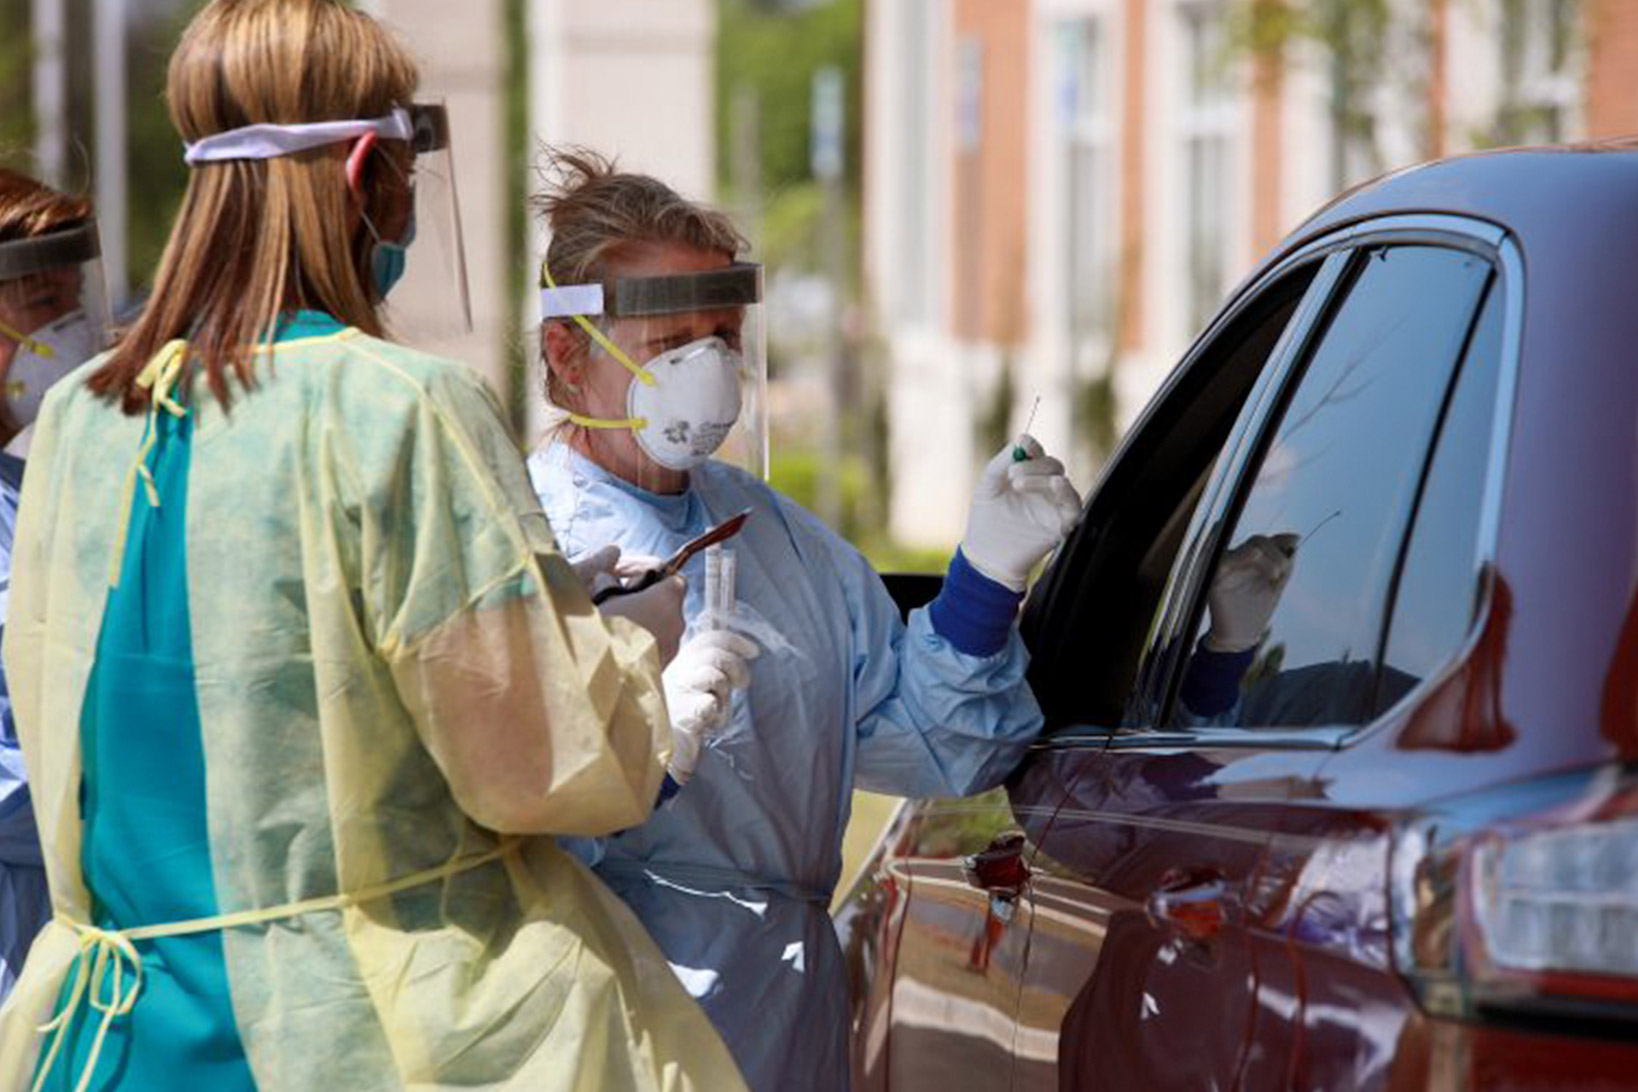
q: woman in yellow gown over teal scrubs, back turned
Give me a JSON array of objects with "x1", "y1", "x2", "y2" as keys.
[{"x1": 0, "y1": 0, "x2": 742, "y2": 1092}]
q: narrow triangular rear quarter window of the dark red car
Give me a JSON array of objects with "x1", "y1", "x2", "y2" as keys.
[{"x1": 1376, "y1": 288, "x2": 1502, "y2": 712}]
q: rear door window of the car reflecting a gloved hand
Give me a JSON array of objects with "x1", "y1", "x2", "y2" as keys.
[{"x1": 1173, "y1": 246, "x2": 1491, "y2": 727}]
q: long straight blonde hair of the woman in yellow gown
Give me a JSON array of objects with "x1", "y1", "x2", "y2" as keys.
[{"x1": 90, "y1": 0, "x2": 419, "y2": 413}]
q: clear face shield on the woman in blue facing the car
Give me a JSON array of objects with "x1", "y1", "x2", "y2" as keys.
[{"x1": 541, "y1": 262, "x2": 768, "y2": 493}]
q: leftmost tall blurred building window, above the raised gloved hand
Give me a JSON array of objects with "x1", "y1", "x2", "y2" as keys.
[{"x1": 1055, "y1": 18, "x2": 1115, "y2": 366}]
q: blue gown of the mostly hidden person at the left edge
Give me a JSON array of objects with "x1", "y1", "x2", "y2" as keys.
[{"x1": 0, "y1": 452, "x2": 51, "y2": 1002}]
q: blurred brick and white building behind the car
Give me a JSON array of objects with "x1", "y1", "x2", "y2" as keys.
[{"x1": 863, "y1": 0, "x2": 1638, "y2": 545}]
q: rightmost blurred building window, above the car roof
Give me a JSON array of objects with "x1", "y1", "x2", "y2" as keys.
[{"x1": 1494, "y1": 0, "x2": 1579, "y2": 144}]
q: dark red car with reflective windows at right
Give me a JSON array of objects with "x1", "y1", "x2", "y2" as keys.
[{"x1": 837, "y1": 146, "x2": 1638, "y2": 1092}]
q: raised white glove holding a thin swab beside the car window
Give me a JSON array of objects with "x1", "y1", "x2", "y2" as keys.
[{"x1": 962, "y1": 435, "x2": 1081, "y2": 591}]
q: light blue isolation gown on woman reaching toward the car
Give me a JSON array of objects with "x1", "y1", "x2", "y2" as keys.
[{"x1": 529, "y1": 444, "x2": 1042, "y2": 1092}]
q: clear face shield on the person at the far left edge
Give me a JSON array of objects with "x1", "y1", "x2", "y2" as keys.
[{"x1": 0, "y1": 221, "x2": 110, "y2": 432}]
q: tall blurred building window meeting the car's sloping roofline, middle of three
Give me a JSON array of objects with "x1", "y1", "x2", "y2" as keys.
[{"x1": 1178, "y1": 3, "x2": 1233, "y2": 336}]
